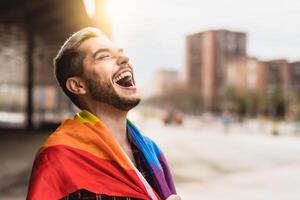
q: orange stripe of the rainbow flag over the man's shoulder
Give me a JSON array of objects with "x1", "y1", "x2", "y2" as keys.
[{"x1": 38, "y1": 119, "x2": 133, "y2": 169}]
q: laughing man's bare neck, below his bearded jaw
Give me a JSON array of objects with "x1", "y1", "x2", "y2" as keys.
[{"x1": 85, "y1": 102, "x2": 128, "y2": 146}]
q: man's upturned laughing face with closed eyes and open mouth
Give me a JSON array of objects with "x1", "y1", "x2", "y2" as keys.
[{"x1": 80, "y1": 36, "x2": 140, "y2": 111}]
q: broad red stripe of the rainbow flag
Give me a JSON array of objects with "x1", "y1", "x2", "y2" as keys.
[{"x1": 27, "y1": 145, "x2": 149, "y2": 200}]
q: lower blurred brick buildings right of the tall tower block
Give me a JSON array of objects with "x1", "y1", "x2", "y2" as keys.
[{"x1": 225, "y1": 58, "x2": 300, "y2": 104}]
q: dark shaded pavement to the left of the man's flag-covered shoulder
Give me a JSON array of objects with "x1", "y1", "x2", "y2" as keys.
[{"x1": 0, "y1": 132, "x2": 49, "y2": 200}]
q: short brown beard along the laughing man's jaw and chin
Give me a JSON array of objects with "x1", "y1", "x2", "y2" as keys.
[{"x1": 85, "y1": 77, "x2": 141, "y2": 111}]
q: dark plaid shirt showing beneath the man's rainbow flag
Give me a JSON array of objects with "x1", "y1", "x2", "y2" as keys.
[{"x1": 61, "y1": 130, "x2": 159, "y2": 200}]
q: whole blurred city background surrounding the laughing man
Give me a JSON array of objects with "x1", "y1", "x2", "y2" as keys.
[{"x1": 0, "y1": 0, "x2": 300, "y2": 200}]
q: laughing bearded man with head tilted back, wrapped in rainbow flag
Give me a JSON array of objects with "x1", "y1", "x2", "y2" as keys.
[{"x1": 27, "y1": 28, "x2": 180, "y2": 200}]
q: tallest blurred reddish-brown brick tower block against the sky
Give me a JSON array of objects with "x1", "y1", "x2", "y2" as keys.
[{"x1": 185, "y1": 30, "x2": 247, "y2": 110}]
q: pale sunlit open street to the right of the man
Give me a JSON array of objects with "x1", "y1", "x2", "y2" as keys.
[{"x1": 139, "y1": 116, "x2": 300, "y2": 200}]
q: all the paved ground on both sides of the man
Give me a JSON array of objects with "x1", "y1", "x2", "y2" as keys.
[{"x1": 0, "y1": 117, "x2": 300, "y2": 200}]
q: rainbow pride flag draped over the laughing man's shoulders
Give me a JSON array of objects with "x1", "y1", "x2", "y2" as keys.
[{"x1": 27, "y1": 111, "x2": 176, "y2": 200}]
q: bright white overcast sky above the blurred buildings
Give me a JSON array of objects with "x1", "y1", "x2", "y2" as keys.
[{"x1": 108, "y1": 0, "x2": 300, "y2": 86}]
